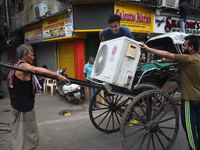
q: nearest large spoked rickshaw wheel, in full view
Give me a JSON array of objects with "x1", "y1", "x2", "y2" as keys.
[{"x1": 121, "y1": 90, "x2": 179, "y2": 150}]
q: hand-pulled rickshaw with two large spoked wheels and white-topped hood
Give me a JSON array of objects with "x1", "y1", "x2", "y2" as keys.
[{"x1": 89, "y1": 33, "x2": 186, "y2": 150}]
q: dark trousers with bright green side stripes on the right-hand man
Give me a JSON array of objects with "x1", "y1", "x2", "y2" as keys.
[{"x1": 181, "y1": 100, "x2": 200, "y2": 150}]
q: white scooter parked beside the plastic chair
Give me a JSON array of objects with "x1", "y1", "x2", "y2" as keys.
[{"x1": 56, "y1": 68, "x2": 82, "y2": 105}]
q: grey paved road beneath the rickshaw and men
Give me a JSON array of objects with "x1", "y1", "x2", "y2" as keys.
[{"x1": 0, "y1": 83, "x2": 189, "y2": 150}]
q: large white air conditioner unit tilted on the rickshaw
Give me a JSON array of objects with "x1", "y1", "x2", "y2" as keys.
[{"x1": 91, "y1": 36, "x2": 141, "y2": 89}]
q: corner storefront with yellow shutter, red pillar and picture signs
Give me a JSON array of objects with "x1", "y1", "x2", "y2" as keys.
[{"x1": 24, "y1": 12, "x2": 86, "y2": 79}]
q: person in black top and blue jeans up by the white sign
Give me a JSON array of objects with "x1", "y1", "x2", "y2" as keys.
[{"x1": 179, "y1": 0, "x2": 189, "y2": 33}]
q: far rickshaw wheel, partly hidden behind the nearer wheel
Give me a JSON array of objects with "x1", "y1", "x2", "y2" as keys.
[{"x1": 89, "y1": 90, "x2": 132, "y2": 133}]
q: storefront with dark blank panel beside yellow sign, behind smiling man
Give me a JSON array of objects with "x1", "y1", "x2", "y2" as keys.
[{"x1": 73, "y1": 2, "x2": 153, "y2": 59}]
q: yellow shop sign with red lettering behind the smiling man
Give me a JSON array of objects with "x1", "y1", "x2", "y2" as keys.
[{"x1": 114, "y1": 2, "x2": 153, "y2": 33}]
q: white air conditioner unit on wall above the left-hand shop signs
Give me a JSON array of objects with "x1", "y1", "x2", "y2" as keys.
[{"x1": 35, "y1": 3, "x2": 49, "y2": 18}]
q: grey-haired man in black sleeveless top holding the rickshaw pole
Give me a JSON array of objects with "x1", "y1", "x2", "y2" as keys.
[{"x1": 7, "y1": 44, "x2": 70, "y2": 150}]
